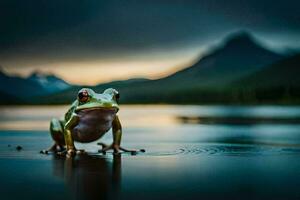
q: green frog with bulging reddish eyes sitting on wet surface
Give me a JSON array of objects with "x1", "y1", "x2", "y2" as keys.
[{"x1": 41, "y1": 88, "x2": 145, "y2": 156}]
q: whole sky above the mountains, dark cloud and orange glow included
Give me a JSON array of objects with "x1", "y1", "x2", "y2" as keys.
[{"x1": 0, "y1": 0, "x2": 300, "y2": 85}]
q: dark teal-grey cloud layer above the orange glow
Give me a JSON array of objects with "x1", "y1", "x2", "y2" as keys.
[{"x1": 0, "y1": 0, "x2": 300, "y2": 67}]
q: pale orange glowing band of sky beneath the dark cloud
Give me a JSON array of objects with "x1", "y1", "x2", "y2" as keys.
[{"x1": 3, "y1": 48, "x2": 203, "y2": 85}]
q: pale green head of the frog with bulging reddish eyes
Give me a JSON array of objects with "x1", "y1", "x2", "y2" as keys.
[{"x1": 76, "y1": 88, "x2": 120, "y2": 111}]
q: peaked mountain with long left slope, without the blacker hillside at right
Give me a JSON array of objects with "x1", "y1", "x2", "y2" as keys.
[{"x1": 36, "y1": 31, "x2": 285, "y2": 103}]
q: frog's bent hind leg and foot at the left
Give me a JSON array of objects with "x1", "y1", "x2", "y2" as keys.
[{"x1": 41, "y1": 118, "x2": 65, "y2": 154}]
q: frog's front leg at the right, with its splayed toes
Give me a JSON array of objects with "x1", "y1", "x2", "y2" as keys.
[{"x1": 98, "y1": 115, "x2": 145, "y2": 154}]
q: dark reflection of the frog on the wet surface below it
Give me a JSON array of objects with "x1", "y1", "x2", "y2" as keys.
[{"x1": 53, "y1": 154, "x2": 121, "y2": 199}]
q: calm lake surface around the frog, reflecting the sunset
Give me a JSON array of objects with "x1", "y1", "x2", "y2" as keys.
[{"x1": 0, "y1": 105, "x2": 300, "y2": 199}]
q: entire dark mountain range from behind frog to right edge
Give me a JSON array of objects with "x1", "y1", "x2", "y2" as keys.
[{"x1": 2, "y1": 32, "x2": 300, "y2": 104}]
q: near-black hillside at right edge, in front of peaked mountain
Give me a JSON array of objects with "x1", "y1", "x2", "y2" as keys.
[{"x1": 228, "y1": 53, "x2": 300, "y2": 104}]
